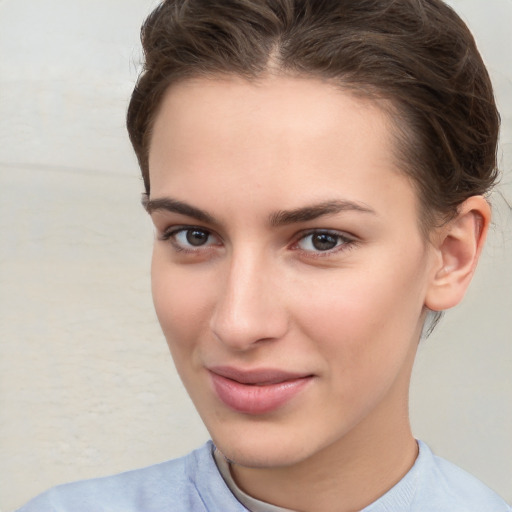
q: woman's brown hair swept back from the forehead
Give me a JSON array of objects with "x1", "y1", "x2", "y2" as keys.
[{"x1": 127, "y1": 0, "x2": 499, "y2": 227}]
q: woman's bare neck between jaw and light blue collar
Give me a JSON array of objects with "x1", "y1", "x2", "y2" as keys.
[{"x1": 231, "y1": 362, "x2": 418, "y2": 512}]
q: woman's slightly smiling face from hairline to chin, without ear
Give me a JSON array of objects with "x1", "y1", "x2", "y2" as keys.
[{"x1": 148, "y1": 77, "x2": 431, "y2": 467}]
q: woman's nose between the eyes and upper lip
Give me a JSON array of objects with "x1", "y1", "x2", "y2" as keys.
[{"x1": 210, "y1": 249, "x2": 288, "y2": 351}]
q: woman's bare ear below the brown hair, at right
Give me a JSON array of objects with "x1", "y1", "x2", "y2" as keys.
[{"x1": 425, "y1": 196, "x2": 491, "y2": 311}]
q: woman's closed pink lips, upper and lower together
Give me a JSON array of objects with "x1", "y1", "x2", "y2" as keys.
[{"x1": 209, "y1": 366, "x2": 313, "y2": 415}]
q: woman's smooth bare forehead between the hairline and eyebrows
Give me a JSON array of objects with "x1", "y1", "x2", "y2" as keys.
[{"x1": 149, "y1": 76, "x2": 416, "y2": 224}]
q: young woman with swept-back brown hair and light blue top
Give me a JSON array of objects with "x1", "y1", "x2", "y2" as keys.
[{"x1": 17, "y1": 0, "x2": 510, "y2": 512}]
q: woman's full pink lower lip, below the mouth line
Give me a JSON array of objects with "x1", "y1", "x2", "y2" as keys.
[{"x1": 210, "y1": 373, "x2": 313, "y2": 414}]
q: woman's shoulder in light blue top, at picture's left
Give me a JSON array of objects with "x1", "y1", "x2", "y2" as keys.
[{"x1": 14, "y1": 442, "x2": 242, "y2": 512}]
